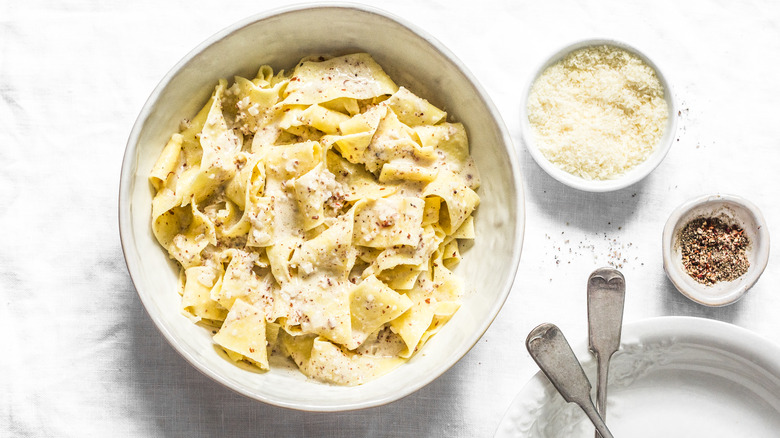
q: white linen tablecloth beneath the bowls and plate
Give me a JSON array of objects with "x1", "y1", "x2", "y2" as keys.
[{"x1": 0, "y1": 0, "x2": 780, "y2": 437}]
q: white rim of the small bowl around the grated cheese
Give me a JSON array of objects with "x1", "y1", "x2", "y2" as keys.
[{"x1": 520, "y1": 37, "x2": 678, "y2": 193}]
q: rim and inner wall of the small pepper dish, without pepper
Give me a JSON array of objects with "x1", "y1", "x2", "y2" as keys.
[{"x1": 661, "y1": 193, "x2": 770, "y2": 307}]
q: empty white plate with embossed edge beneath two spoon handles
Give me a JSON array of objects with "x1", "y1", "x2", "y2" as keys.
[{"x1": 496, "y1": 317, "x2": 780, "y2": 438}]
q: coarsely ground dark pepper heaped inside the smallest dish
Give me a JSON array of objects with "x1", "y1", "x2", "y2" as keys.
[{"x1": 679, "y1": 218, "x2": 750, "y2": 285}]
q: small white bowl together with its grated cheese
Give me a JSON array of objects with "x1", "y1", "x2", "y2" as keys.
[{"x1": 521, "y1": 39, "x2": 677, "y2": 192}]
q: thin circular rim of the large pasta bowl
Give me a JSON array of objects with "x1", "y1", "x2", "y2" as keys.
[{"x1": 118, "y1": 2, "x2": 525, "y2": 412}]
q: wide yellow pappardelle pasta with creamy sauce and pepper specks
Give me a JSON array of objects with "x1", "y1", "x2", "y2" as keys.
[{"x1": 149, "y1": 53, "x2": 479, "y2": 385}]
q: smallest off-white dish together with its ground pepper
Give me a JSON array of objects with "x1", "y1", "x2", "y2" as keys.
[{"x1": 663, "y1": 194, "x2": 769, "y2": 307}]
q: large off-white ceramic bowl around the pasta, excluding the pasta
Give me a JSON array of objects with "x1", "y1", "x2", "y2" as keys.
[{"x1": 119, "y1": 5, "x2": 524, "y2": 411}]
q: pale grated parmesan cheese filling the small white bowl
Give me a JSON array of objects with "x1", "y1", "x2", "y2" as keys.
[{"x1": 527, "y1": 46, "x2": 668, "y2": 180}]
